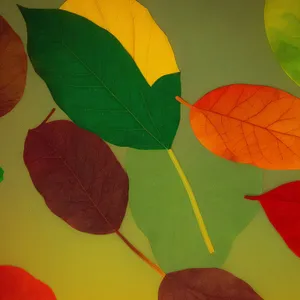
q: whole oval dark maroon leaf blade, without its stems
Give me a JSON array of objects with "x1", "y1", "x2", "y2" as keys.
[{"x1": 24, "y1": 115, "x2": 129, "y2": 234}]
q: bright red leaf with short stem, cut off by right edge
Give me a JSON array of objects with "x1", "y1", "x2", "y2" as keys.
[{"x1": 245, "y1": 181, "x2": 300, "y2": 257}]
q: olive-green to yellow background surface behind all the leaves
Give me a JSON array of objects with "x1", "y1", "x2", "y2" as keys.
[{"x1": 0, "y1": 0, "x2": 300, "y2": 300}]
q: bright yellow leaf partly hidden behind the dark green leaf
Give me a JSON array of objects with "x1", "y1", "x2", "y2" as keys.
[{"x1": 61, "y1": 0, "x2": 178, "y2": 85}]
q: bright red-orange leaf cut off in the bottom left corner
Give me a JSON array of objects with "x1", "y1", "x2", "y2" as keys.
[{"x1": 0, "y1": 266, "x2": 56, "y2": 300}]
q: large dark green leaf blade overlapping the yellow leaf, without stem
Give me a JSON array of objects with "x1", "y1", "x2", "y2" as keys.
[{"x1": 20, "y1": 7, "x2": 180, "y2": 149}]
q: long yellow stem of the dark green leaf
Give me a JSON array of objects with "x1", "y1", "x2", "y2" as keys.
[{"x1": 167, "y1": 149, "x2": 215, "y2": 254}]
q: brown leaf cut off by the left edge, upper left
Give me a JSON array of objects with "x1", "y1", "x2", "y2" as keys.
[{"x1": 0, "y1": 16, "x2": 27, "y2": 117}]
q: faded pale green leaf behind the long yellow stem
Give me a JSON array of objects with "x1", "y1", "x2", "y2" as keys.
[{"x1": 125, "y1": 125, "x2": 262, "y2": 273}]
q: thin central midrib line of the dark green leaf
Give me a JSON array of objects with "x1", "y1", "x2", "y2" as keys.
[{"x1": 61, "y1": 37, "x2": 168, "y2": 149}]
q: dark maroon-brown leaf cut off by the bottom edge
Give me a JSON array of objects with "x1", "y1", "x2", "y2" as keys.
[{"x1": 158, "y1": 269, "x2": 262, "y2": 300}]
